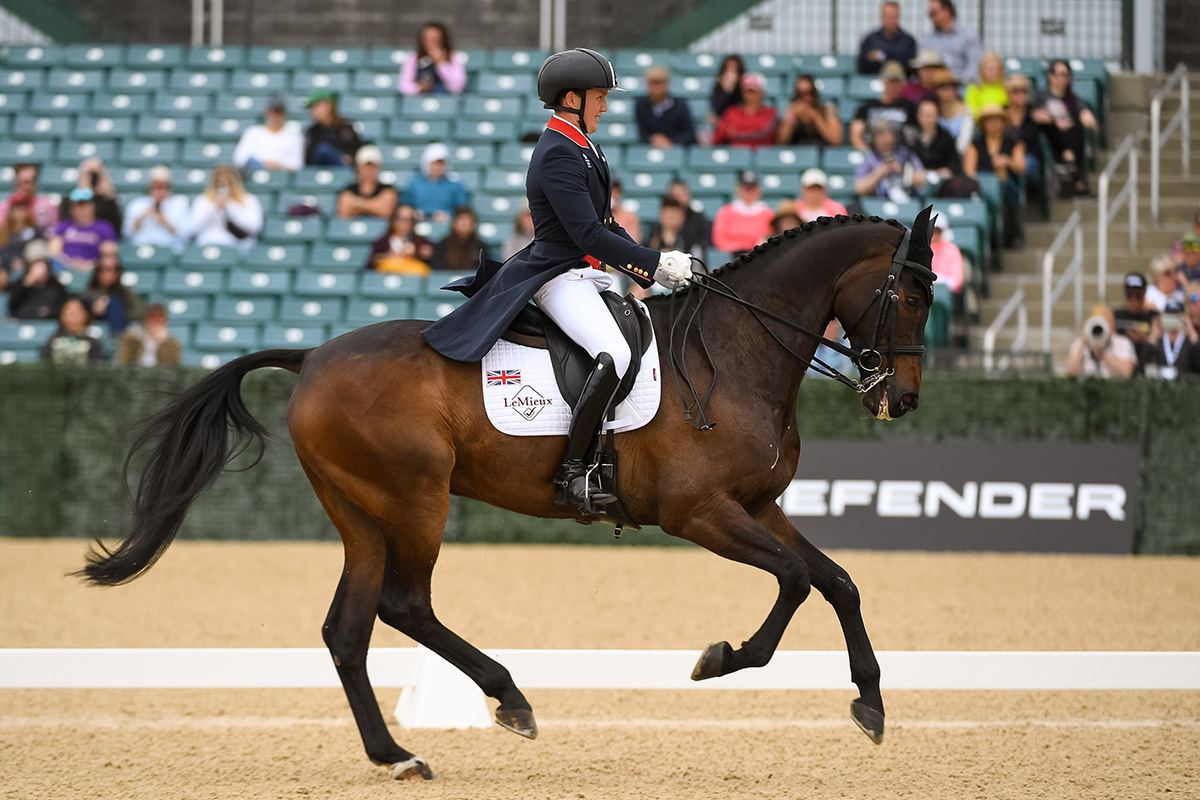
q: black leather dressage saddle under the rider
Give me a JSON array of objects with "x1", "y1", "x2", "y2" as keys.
[{"x1": 500, "y1": 291, "x2": 653, "y2": 409}]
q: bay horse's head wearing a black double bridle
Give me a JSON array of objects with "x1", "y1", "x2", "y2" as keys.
[{"x1": 834, "y1": 206, "x2": 935, "y2": 420}]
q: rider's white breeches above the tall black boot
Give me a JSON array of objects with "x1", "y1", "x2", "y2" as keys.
[{"x1": 533, "y1": 267, "x2": 632, "y2": 377}]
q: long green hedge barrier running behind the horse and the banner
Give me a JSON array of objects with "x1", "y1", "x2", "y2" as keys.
[{"x1": 0, "y1": 365, "x2": 1200, "y2": 554}]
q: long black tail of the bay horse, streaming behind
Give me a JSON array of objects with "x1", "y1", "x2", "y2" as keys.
[{"x1": 77, "y1": 350, "x2": 308, "y2": 587}]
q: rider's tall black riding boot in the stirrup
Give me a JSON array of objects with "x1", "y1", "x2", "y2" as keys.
[{"x1": 554, "y1": 353, "x2": 620, "y2": 513}]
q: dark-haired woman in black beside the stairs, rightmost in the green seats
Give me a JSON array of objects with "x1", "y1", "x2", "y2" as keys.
[{"x1": 1031, "y1": 59, "x2": 1096, "y2": 197}]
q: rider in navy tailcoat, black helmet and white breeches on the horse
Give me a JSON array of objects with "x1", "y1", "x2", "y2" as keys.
[{"x1": 424, "y1": 48, "x2": 691, "y2": 513}]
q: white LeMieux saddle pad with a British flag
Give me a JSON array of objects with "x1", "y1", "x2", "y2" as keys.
[{"x1": 481, "y1": 314, "x2": 662, "y2": 437}]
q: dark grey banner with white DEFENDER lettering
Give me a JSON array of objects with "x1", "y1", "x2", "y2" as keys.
[{"x1": 780, "y1": 440, "x2": 1139, "y2": 553}]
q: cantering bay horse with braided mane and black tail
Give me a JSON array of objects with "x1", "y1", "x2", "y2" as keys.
[{"x1": 80, "y1": 209, "x2": 934, "y2": 780}]
